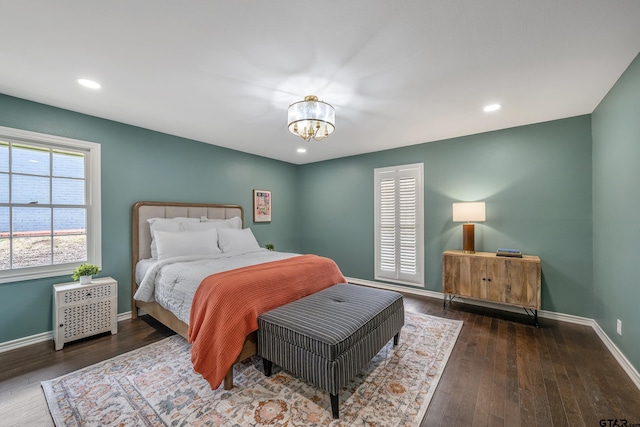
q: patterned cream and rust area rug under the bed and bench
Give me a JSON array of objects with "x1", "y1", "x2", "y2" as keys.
[{"x1": 42, "y1": 312, "x2": 462, "y2": 426}]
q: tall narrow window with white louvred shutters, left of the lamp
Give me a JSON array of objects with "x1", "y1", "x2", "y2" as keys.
[{"x1": 374, "y1": 163, "x2": 424, "y2": 286}]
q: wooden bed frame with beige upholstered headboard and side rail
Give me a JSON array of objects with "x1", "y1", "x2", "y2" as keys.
[{"x1": 131, "y1": 202, "x2": 252, "y2": 390}]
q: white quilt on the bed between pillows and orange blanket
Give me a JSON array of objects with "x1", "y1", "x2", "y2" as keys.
[{"x1": 134, "y1": 249, "x2": 299, "y2": 324}]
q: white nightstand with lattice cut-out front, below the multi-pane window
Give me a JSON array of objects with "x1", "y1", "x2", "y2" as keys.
[{"x1": 53, "y1": 277, "x2": 118, "y2": 350}]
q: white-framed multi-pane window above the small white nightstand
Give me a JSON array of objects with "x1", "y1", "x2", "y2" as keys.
[{"x1": 0, "y1": 127, "x2": 102, "y2": 283}]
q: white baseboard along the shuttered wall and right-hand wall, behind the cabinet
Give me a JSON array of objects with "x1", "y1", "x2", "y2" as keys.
[{"x1": 346, "y1": 277, "x2": 640, "y2": 389}]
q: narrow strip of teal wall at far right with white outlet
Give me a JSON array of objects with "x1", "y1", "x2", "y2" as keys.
[{"x1": 592, "y1": 55, "x2": 640, "y2": 370}]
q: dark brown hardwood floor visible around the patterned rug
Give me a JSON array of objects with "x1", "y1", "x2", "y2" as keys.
[{"x1": 0, "y1": 295, "x2": 640, "y2": 427}]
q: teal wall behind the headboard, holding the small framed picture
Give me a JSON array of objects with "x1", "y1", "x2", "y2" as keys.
[{"x1": 0, "y1": 94, "x2": 299, "y2": 343}]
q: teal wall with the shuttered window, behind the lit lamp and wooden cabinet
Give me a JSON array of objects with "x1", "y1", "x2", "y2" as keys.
[{"x1": 298, "y1": 116, "x2": 593, "y2": 317}]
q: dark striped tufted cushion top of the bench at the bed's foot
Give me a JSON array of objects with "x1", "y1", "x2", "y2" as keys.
[{"x1": 258, "y1": 283, "x2": 403, "y2": 361}]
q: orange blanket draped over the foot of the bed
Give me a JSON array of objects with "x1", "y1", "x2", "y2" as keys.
[{"x1": 189, "y1": 255, "x2": 347, "y2": 389}]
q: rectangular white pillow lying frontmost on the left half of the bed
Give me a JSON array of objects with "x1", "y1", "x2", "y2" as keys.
[{"x1": 155, "y1": 229, "x2": 220, "y2": 259}]
